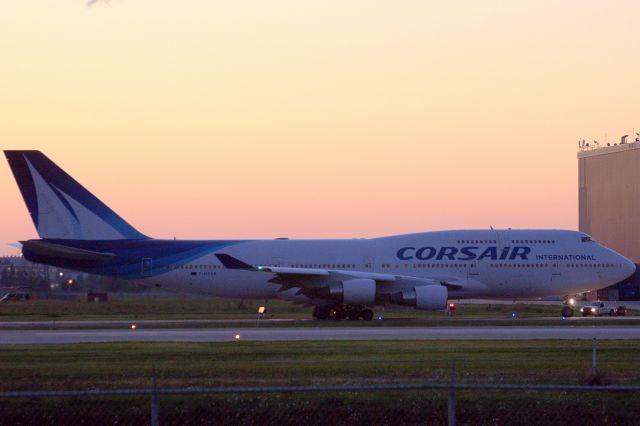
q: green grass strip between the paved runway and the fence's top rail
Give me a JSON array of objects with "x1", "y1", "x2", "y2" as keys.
[{"x1": 5, "y1": 340, "x2": 640, "y2": 390}]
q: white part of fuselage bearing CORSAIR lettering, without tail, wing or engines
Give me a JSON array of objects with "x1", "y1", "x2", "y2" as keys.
[{"x1": 139, "y1": 230, "x2": 635, "y2": 302}]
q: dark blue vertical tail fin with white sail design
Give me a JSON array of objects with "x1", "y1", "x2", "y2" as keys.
[{"x1": 4, "y1": 151, "x2": 148, "y2": 240}]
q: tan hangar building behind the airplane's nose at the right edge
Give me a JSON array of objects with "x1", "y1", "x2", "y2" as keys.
[{"x1": 578, "y1": 136, "x2": 640, "y2": 300}]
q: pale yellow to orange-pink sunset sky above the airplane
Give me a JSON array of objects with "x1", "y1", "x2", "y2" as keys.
[{"x1": 0, "y1": 0, "x2": 640, "y2": 254}]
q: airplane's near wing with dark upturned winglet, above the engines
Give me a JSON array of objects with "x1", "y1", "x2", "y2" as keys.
[{"x1": 216, "y1": 253, "x2": 463, "y2": 291}]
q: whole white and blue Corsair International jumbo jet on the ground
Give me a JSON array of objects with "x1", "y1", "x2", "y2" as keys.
[{"x1": 4, "y1": 150, "x2": 636, "y2": 320}]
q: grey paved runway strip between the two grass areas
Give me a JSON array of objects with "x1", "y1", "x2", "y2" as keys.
[{"x1": 0, "y1": 326, "x2": 640, "y2": 345}]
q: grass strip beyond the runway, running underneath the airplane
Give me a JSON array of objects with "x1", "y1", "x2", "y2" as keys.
[{"x1": 0, "y1": 296, "x2": 640, "y2": 329}]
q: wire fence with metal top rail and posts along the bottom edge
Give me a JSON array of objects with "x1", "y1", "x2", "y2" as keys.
[{"x1": 0, "y1": 380, "x2": 640, "y2": 426}]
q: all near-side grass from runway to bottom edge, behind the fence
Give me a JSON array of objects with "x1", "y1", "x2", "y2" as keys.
[{"x1": 0, "y1": 341, "x2": 640, "y2": 424}]
